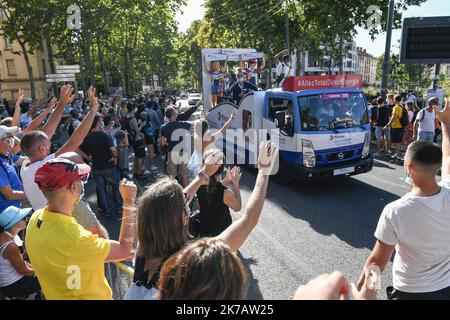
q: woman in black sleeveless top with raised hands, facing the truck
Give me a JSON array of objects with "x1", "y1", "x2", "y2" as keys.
[{"x1": 197, "y1": 156, "x2": 242, "y2": 237}]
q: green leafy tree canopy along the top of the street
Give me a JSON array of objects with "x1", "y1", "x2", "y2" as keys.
[{"x1": 0, "y1": 0, "x2": 425, "y2": 93}]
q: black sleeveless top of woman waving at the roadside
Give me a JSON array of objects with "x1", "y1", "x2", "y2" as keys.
[{"x1": 197, "y1": 183, "x2": 232, "y2": 237}]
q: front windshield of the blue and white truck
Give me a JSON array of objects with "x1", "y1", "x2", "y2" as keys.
[{"x1": 298, "y1": 93, "x2": 369, "y2": 131}]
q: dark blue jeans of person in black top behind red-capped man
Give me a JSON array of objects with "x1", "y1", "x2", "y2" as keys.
[{"x1": 92, "y1": 168, "x2": 122, "y2": 212}]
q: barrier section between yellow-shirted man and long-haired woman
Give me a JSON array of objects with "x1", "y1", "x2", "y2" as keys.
[{"x1": 105, "y1": 262, "x2": 134, "y2": 300}]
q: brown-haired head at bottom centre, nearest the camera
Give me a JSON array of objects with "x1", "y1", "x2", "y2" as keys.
[{"x1": 157, "y1": 238, "x2": 247, "y2": 300}]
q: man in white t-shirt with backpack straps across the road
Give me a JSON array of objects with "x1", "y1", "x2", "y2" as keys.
[{"x1": 413, "y1": 98, "x2": 439, "y2": 142}]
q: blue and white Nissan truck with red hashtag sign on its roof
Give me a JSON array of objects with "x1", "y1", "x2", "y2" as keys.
[{"x1": 207, "y1": 71, "x2": 373, "y2": 182}]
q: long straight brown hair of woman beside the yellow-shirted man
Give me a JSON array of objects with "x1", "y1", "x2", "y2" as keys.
[{"x1": 137, "y1": 177, "x2": 189, "y2": 259}]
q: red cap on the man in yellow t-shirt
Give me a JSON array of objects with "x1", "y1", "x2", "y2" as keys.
[{"x1": 34, "y1": 158, "x2": 91, "y2": 191}]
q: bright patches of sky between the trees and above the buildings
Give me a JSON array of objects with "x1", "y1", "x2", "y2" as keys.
[{"x1": 177, "y1": 0, "x2": 450, "y2": 56}]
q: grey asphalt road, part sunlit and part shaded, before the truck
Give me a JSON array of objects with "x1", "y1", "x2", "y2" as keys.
[{"x1": 87, "y1": 99, "x2": 418, "y2": 299}]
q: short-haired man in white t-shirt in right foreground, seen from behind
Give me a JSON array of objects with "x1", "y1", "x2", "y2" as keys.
[{"x1": 358, "y1": 100, "x2": 450, "y2": 300}]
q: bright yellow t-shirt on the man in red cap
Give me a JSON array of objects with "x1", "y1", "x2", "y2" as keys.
[{"x1": 25, "y1": 207, "x2": 112, "y2": 300}]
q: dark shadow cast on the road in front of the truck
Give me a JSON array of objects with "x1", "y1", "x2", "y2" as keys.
[{"x1": 241, "y1": 170, "x2": 399, "y2": 249}]
